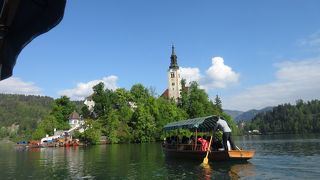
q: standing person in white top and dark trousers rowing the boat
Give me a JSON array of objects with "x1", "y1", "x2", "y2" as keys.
[{"x1": 214, "y1": 117, "x2": 236, "y2": 151}]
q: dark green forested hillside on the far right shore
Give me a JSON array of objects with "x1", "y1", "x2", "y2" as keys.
[{"x1": 245, "y1": 100, "x2": 320, "y2": 134}]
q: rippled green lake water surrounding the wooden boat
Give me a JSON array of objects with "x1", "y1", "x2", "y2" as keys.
[{"x1": 0, "y1": 134, "x2": 320, "y2": 179}]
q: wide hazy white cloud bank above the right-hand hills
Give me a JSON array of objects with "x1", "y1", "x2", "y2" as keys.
[{"x1": 223, "y1": 58, "x2": 320, "y2": 110}]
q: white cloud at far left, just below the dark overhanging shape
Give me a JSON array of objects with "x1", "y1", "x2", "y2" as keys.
[{"x1": 0, "y1": 77, "x2": 41, "y2": 95}]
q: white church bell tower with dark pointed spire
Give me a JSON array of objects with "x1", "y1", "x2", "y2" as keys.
[{"x1": 168, "y1": 45, "x2": 181, "y2": 102}]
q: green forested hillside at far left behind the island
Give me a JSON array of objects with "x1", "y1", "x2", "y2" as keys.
[{"x1": 0, "y1": 94, "x2": 53, "y2": 137}]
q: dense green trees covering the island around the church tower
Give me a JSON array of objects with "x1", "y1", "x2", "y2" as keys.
[{"x1": 82, "y1": 82, "x2": 225, "y2": 143}]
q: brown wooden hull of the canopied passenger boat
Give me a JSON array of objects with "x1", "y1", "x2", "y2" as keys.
[{"x1": 163, "y1": 148, "x2": 255, "y2": 161}]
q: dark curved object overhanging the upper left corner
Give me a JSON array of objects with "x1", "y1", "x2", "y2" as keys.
[{"x1": 0, "y1": 0, "x2": 66, "y2": 81}]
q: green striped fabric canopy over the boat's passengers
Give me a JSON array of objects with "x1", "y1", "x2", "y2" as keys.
[{"x1": 163, "y1": 116, "x2": 219, "y2": 132}]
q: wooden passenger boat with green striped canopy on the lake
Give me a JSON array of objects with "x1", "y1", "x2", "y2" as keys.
[{"x1": 163, "y1": 115, "x2": 255, "y2": 161}]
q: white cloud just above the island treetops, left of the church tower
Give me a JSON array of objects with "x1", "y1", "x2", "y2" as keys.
[{"x1": 58, "y1": 75, "x2": 118, "y2": 100}]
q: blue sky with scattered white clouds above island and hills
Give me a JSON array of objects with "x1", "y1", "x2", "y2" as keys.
[{"x1": 0, "y1": 0, "x2": 320, "y2": 111}]
